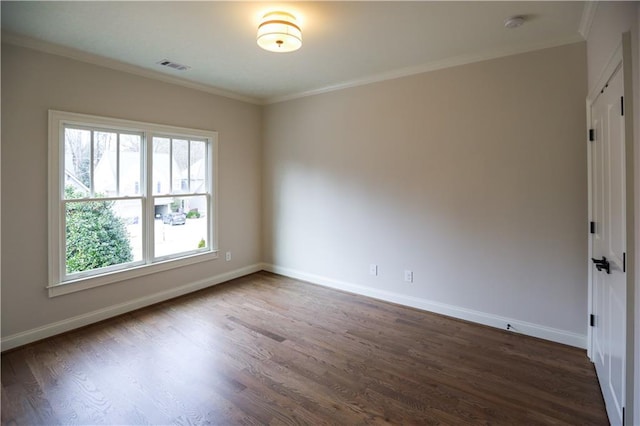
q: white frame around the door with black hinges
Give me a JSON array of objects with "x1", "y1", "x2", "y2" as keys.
[{"x1": 585, "y1": 32, "x2": 640, "y2": 425}]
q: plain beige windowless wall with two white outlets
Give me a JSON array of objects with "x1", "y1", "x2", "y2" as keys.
[{"x1": 263, "y1": 43, "x2": 587, "y2": 345}]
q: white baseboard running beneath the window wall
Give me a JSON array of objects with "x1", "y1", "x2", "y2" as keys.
[{"x1": 0, "y1": 263, "x2": 264, "y2": 351}]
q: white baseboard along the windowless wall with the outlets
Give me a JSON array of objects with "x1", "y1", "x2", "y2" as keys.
[{"x1": 263, "y1": 264, "x2": 587, "y2": 349}]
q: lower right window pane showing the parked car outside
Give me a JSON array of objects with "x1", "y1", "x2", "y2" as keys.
[{"x1": 154, "y1": 196, "x2": 209, "y2": 257}]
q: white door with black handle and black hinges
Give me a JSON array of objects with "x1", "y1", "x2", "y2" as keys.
[{"x1": 590, "y1": 67, "x2": 627, "y2": 425}]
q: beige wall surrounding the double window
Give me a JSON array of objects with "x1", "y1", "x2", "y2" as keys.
[{"x1": 2, "y1": 45, "x2": 262, "y2": 338}]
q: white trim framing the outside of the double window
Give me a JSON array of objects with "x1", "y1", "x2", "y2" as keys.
[{"x1": 47, "y1": 110, "x2": 218, "y2": 297}]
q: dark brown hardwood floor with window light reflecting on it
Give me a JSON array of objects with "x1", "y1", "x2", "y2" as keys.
[{"x1": 2, "y1": 272, "x2": 608, "y2": 425}]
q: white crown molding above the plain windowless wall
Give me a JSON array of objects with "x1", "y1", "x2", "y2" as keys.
[{"x1": 264, "y1": 34, "x2": 584, "y2": 105}]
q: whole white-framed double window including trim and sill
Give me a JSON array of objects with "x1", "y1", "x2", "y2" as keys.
[{"x1": 48, "y1": 111, "x2": 217, "y2": 296}]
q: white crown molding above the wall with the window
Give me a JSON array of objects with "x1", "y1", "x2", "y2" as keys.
[{"x1": 2, "y1": 31, "x2": 264, "y2": 105}]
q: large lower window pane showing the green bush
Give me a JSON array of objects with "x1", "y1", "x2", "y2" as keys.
[{"x1": 65, "y1": 200, "x2": 142, "y2": 274}]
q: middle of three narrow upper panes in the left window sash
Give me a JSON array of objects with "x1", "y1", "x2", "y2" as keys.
[{"x1": 93, "y1": 132, "x2": 118, "y2": 197}]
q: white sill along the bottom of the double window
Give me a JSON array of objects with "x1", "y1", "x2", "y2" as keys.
[{"x1": 47, "y1": 251, "x2": 218, "y2": 297}]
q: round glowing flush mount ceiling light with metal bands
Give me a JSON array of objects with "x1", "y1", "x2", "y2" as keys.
[{"x1": 257, "y1": 12, "x2": 302, "y2": 53}]
